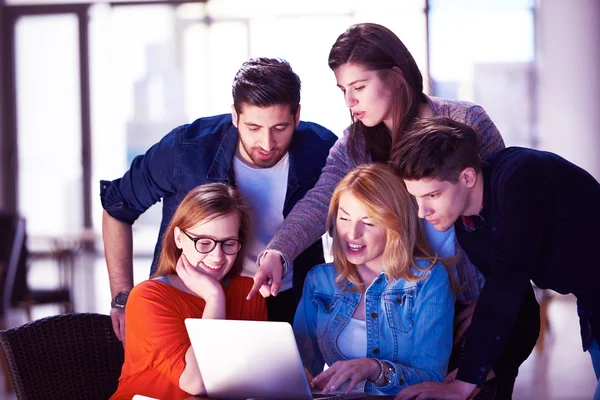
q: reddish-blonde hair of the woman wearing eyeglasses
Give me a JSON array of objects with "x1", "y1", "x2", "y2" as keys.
[{"x1": 152, "y1": 183, "x2": 251, "y2": 278}]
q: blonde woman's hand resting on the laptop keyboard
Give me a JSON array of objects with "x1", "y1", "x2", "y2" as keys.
[{"x1": 311, "y1": 358, "x2": 380, "y2": 394}]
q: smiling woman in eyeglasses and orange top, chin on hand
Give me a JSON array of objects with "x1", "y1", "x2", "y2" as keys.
[{"x1": 111, "y1": 183, "x2": 267, "y2": 400}]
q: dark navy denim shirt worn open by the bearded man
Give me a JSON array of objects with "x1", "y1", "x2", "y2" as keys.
[{"x1": 100, "y1": 114, "x2": 337, "y2": 278}]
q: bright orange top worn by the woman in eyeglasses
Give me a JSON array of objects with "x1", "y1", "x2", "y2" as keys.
[{"x1": 111, "y1": 276, "x2": 267, "y2": 400}]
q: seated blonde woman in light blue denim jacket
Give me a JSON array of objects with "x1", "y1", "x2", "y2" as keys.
[{"x1": 294, "y1": 164, "x2": 454, "y2": 395}]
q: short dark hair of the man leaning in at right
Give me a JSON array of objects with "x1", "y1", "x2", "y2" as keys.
[{"x1": 390, "y1": 117, "x2": 481, "y2": 182}]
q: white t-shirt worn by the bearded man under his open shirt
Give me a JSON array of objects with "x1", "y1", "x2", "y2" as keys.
[{"x1": 233, "y1": 153, "x2": 292, "y2": 291}]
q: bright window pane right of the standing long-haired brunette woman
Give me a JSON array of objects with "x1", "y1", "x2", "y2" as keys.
[{"x1": 429, "y1": 0, "x2": 537, "y2": 147}]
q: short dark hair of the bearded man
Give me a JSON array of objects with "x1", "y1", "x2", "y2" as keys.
[{"x1": 231, "y1": 57, "x2": 301, "y2": 118}]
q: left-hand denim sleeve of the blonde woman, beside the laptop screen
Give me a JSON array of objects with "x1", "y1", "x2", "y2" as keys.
[{"x1": 293, "y1": 270, "x2": 325, "y2": 376}]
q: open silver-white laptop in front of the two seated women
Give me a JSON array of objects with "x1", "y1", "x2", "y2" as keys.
[{"x1": 185, "y1": 318, "x2": 367, "y2": 400}]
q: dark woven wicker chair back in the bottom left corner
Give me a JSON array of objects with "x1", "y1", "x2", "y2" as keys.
[{"x1": 0, "y1": 313, "x2": 124, "y2": 400}]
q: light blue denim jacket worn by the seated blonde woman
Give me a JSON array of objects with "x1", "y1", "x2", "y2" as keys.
[{"x1": 294, "y1": 260, "x2": 454, "y2": 395}]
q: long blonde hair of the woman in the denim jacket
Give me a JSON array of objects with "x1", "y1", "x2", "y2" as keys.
[{"x1": 327, "y1": 163, "x2": 436, "y2": 291}]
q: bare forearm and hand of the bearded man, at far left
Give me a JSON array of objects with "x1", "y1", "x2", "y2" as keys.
[{"x1": 102, "y1": 210, "x2": 133, "y2": 340}]
